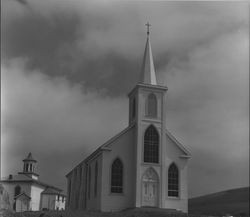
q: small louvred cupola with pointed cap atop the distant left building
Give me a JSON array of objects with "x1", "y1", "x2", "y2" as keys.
[{"x1": 19, "y1": 152, "x2": 39, "y2": 180}]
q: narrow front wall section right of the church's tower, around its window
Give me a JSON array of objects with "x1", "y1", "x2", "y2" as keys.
[{"x1": 165, "y1": 137, "x2": 188, "y2": 212}]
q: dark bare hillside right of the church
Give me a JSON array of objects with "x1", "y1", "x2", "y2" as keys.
[{"x1": 189, "y1": 187, "x2": 249, "y2": 216}]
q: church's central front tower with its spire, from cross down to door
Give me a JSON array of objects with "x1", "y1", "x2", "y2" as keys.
[{"x1": 128, "y1": 23, "x2": 168, "y2": 207}]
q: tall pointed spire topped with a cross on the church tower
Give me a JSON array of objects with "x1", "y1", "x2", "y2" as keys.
[{"x1": 140, "y1": 23, "x2": 157, "y2": 85}]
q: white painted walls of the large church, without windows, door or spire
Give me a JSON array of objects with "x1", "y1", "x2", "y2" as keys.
[{"x1": 67, "y1": 84, "x2": 188, "y2": 212}]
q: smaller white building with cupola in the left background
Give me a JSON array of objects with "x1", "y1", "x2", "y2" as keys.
[{"x1": 0, "y1": 153, "x2": 66, "y2": 212}]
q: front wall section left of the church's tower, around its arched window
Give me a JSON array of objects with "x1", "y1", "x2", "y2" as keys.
[{"x1": 101, "y1": 127, "x2": 136, "y2": 211}]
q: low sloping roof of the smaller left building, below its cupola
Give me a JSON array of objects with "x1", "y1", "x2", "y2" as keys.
[{"x1": 0, "y1": 173, "x2": 62, "y2": 192}]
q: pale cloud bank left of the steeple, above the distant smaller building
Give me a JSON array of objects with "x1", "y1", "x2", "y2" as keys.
[{"x1": 2, "y1": 59, "x2": 127, "y2": 189}]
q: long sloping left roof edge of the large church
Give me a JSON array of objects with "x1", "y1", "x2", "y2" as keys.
[{"x1": 66, "y1": 124, "x2": 135, "y2": 177}]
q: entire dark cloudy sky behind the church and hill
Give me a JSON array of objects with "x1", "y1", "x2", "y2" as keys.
[{"x1": 1, "y1": 0, "x2": 249, "y2": 197}]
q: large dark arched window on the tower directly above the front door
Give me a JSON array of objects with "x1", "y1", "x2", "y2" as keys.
[{"x1": 144, "y1": 125, "x2": 159, "y2": 163}]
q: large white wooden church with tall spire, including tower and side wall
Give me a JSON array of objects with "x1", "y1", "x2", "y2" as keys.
[{"x1": 66, "y1": 24, "x2": 191, "y2": 213}]
